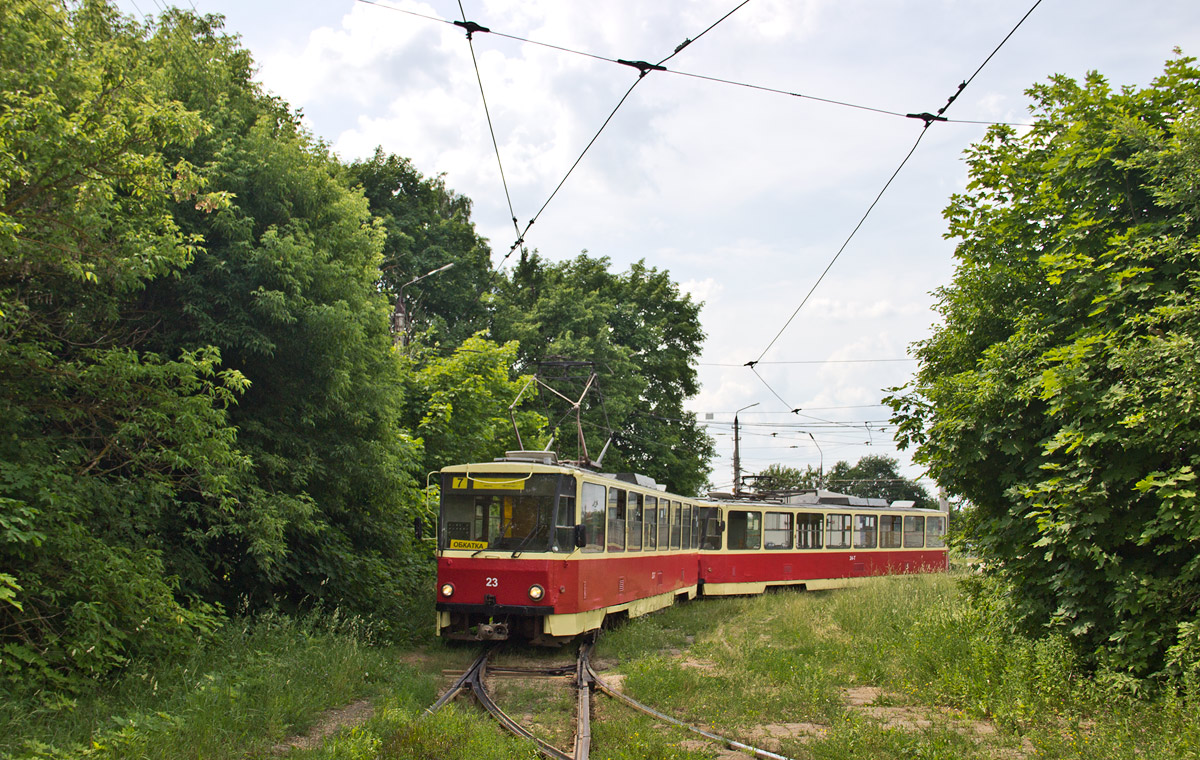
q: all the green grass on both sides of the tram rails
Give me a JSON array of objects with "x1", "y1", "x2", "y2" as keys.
[{"x1": 0, "y1": 576, "x2": 1200, "y2": 760}]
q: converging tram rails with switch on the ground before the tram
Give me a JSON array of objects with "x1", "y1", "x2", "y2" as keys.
[{"x1": 427, "y1": 638, "x2": 790, "y2": 760}]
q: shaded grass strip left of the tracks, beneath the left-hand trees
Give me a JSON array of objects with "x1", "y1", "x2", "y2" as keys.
[{"x1": 0, "y1": 615, "x2": 436, "y2": 760}]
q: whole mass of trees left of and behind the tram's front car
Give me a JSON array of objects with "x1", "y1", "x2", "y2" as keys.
[{"x1": 0, "y1": 0, "x2": 712, "y2": 694}]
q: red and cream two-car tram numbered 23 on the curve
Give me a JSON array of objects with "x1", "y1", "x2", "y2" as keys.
[{"x1": 437, "y1": 451, "x2": 947, "y2": 644}]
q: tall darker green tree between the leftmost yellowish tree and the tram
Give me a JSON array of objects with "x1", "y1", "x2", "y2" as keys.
[{"x1": 139, "y1": 11, "x2": 420, "y2": 623}]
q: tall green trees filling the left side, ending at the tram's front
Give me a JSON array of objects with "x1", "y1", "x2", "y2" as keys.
[{"x1": 0, "y1": 1, "x2": 424, "y2": 689}]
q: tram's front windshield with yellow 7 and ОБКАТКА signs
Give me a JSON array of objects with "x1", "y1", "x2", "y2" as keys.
[{"x1": 438, "y1": 473, "x2": 575, "y2": 553}]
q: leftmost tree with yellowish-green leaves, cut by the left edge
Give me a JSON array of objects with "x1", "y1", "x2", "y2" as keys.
[{"x1": 0, "y1": 0, "x2": 243, "y2": 690}]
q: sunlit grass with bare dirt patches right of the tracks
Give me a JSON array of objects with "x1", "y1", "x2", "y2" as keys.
[{"x1": 599, "y1": 576, "x2": 1200, "y2": 760}]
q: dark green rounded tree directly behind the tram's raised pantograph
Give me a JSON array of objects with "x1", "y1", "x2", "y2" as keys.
[{"x1": 492, "y1": 251, "x2": 713, "y2": 493}]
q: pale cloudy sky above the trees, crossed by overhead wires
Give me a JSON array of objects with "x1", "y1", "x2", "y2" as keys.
[{"x1": 118, "y1": 0, "x2": 1200, "y2": 489}]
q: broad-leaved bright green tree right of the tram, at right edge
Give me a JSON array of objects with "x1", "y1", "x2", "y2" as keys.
[{"x1": 892, "y1": 58, "x2": 1200, "y2": 674}]
